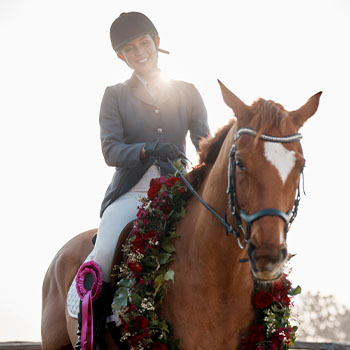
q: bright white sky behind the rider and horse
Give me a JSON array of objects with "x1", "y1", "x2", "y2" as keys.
[{"x1": 0, "y1": 0, "x2": 350, "y2": 341}]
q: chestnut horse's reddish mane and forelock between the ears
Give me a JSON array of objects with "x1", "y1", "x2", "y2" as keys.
[{"x1": 187, "y1": 98, "x2": 288, "y2": 189}]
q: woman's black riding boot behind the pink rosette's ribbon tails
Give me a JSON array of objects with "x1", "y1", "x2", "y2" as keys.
[{"x1": 74, "y1": 282, "x2": 113, "y2": 350}]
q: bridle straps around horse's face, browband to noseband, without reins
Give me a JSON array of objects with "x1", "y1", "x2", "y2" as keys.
[{"x1": 227, "y1": 128, "x2": 302, "y2": 249}]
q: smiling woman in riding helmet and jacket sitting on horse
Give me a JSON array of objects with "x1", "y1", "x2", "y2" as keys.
[{"x1": 76, "y1": 12, "x2": 209, "y2": 349}]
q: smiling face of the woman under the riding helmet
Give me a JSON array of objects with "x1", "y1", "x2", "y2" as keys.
[{"x1": 118, "y1": 34, "x2": 159, "y2": 75}]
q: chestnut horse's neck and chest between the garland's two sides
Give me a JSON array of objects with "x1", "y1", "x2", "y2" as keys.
[{"x1": 164, "y1": 128, "x2": 254, "y2": 350}]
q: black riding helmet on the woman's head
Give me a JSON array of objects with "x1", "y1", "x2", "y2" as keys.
[{"x1": 110, "y1": 12, "x2": 169, "y2": 53}]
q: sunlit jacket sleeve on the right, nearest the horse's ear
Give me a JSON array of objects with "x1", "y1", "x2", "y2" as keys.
[{"x1": 189, "y1": 84, "x2": 210, "y2": 151}]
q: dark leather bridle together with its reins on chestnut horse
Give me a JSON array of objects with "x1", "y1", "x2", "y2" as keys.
[{"x1": 168, "y1": 128, "x2": 303, "y2": 253}]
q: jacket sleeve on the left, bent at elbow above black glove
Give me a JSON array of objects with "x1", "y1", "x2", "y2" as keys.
[{"x1": 99, "y1": 87, "x2": 144, "y2": 168}]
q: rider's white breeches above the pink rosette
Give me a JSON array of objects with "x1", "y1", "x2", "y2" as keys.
[{"x1": 94, "y1": 166, "x2": 159, "y2": 282}]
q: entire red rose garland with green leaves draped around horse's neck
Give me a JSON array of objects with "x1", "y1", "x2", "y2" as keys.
[{"x1": 112, "y1": 170, "x2": 301, "y2": 350}]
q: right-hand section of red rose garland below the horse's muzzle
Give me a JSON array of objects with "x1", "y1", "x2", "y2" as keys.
[{"x1": 241, "y1": 274, "x2": 301, "y2": 350}]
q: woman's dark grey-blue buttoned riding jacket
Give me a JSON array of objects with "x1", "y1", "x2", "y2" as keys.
[{"x1": 100, "y1": 74, "x2": 209, "y2": 216}]
